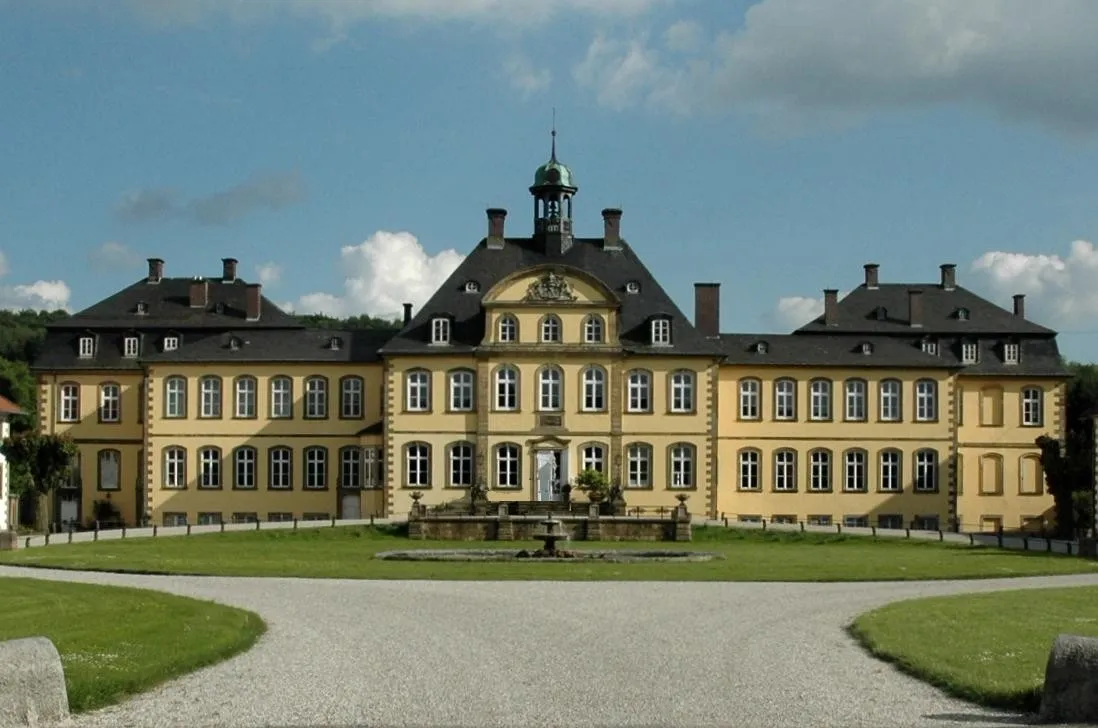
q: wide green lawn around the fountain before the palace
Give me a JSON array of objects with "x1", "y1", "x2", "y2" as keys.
[{"x1": 0, "y1": 526, "x2": 1098, "y2": 581}]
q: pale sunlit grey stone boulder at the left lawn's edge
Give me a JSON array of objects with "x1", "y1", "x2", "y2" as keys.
[{"x1": 0, "y1": 636, "x2": 69, "y2": 726}]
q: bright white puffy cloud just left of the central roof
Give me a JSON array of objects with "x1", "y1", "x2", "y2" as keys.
[{"x1": 289, "y1": 231, "x2": 463, "y2": 318}]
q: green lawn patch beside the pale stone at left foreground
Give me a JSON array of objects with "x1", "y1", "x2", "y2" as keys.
[{"x1": 0, "y1": 578, "x2": 266, "y2": 713}]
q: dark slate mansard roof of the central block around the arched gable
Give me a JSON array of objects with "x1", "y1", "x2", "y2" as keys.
[{"x1": 381, "y1": 237, "x2": 720, "y2": 357}]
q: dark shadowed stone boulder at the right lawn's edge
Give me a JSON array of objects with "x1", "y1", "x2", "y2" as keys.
[{"x1": 1038, "y1": 635, "x2": 1098, "y2": 723}]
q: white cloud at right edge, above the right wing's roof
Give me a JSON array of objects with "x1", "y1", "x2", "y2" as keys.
[{"x1": 972, "y1": 240, "x2": 1098, "y2": 328}]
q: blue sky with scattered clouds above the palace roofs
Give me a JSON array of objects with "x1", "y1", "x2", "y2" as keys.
[{"x1": 0, "y1": 0, "x2": 1098, "y2": 361}]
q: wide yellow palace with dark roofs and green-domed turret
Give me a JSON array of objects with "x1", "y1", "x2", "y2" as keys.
[{"x1": 35, "y1": 145, "x2": 1067, "y2": 530}]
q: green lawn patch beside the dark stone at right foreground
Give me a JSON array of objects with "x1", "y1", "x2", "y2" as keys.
[{"x1": 851, "y1": 586, "x2": 1098, "y2": 712}]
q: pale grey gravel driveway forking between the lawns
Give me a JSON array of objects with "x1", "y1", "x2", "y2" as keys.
[{"x1": 0, "y1": 567, "x2": 1098, "y2": 728}]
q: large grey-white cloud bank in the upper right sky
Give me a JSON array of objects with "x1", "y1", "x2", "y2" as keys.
[{"x1": 575, "y1": 0, "x2": 1098, "y2": 133}]
